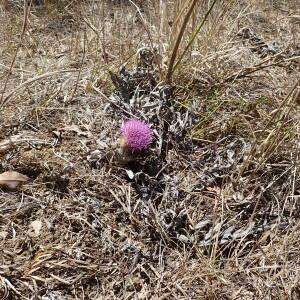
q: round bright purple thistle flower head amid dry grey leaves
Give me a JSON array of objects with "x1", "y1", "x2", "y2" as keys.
[{"x1": 121, "y1": 120, "x2": 152, "y2": 151}]
